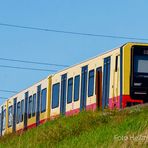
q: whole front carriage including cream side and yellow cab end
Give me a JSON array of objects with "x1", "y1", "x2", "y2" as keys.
[{"x1": 51, "y1": 43, "x2": 148, "y2": 118}]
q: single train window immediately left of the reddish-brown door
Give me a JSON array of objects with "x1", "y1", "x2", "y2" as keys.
[{"x1": 88, "y1": 70, "x2": 94, "y2": 97}]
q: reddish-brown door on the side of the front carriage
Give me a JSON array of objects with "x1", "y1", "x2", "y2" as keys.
[{"x1": 96, "y1": 67, "x2": 102, "y2": 108}]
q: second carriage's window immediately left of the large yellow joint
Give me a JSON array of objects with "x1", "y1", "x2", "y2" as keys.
[{"x1": 41, "y1": 88, "x2": 47, "y2": 113}]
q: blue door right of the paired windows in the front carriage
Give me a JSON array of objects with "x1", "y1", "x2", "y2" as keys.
[{"x1": 80, "y1": 66, "x2": 88, "y2": 111}]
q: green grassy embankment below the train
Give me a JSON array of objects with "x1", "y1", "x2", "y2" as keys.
[{"x1": 0, "y1": 105, "x2": 148, "y2": 148}]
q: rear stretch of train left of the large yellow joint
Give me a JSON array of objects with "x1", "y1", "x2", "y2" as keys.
[{"x1": 1, "y1": 76, "x2": 51, "y2": 135}]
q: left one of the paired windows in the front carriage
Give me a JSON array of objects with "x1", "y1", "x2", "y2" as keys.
[{"x1": 67, "y1": 78, "x2": 73, "y2": 103}]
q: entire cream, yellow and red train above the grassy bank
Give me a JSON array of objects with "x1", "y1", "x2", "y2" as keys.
[{"x1": 0, "y1": 42, "x2": 148, "y2": 136}]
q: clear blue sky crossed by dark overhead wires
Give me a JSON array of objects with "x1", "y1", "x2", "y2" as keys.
[{"x1": 0, "y1": 0, "x2": 148, "y2": 104}]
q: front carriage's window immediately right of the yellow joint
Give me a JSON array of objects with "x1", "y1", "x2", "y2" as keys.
[{"x1": 52, "y1": 83, "x2": 60, "y2": 108}]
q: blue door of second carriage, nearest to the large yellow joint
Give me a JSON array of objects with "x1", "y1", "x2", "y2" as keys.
[{"x1": 36, "y1": 85, "x2": 41, "y2": 126}]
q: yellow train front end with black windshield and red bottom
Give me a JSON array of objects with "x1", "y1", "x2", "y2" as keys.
[{"x1": 120, "y1": 43, "x2": 148, "y2": 107}]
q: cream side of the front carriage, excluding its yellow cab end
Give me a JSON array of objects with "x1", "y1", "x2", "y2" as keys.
[{"x1": 51, "y1": 45, "x2": 120, "y2": 118}]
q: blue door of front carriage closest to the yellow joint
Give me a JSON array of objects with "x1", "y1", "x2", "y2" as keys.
[{"x1": 60, "y1": 74, "x2": 67, "y2": 115}]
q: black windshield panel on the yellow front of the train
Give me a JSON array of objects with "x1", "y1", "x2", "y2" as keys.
[{"x1": 130, "y1": 45, "x2": 148, "y2": 102}]
